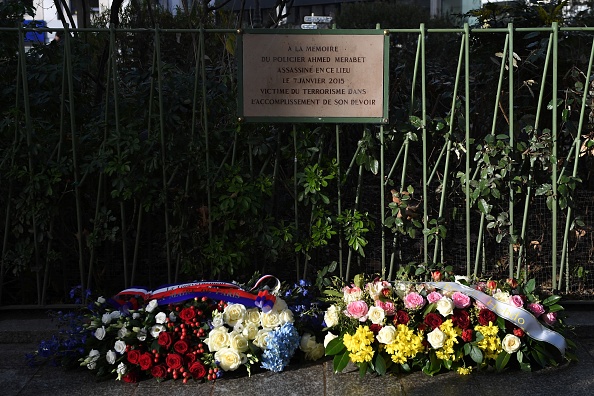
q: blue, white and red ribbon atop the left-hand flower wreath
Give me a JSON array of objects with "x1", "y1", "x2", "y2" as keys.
[{"x1": 113, "y1": 275, "x2": 280, "y2": 312}]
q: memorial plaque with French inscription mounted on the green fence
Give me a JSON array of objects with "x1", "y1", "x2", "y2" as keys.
[{"x1": 239, "y1": 30, "x2": 388, "y2": 123}]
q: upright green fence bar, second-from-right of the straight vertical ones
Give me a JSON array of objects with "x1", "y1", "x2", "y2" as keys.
[{"x1": 507, "y1": 23, "x2": 515, "y2": 278}]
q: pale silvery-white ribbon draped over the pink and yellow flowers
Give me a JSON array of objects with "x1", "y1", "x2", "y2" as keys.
[{"x1": 427, "y1": 282, "x2": 567, "y2": 356}]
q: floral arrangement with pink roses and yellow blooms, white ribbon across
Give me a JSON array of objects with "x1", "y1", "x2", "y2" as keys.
[{"x1": 324, "y1": 271, "x2": 575, "y2": 375}]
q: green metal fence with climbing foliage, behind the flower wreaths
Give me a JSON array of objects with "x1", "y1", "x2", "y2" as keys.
[{"x1": 0, "y1": 24, "x2": 594, "y2": 304}]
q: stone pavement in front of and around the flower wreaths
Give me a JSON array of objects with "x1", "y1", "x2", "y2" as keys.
[{"x1": 0, "y1": 310, "x2": 594, "y2": 396}]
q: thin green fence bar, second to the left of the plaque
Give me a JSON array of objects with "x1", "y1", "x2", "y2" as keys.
[{"x1": 154, "y1": 25, "x2": 172, "y2": 283}]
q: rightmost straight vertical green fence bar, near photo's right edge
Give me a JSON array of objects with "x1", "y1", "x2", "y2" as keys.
[{"x1": 551, "y1": 22, "x2": 559, "y2": 285}]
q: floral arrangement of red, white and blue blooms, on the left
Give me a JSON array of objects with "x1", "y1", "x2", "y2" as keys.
[{"x1": 67, "y1": 276, "x2": 324, "y2": 382}]
